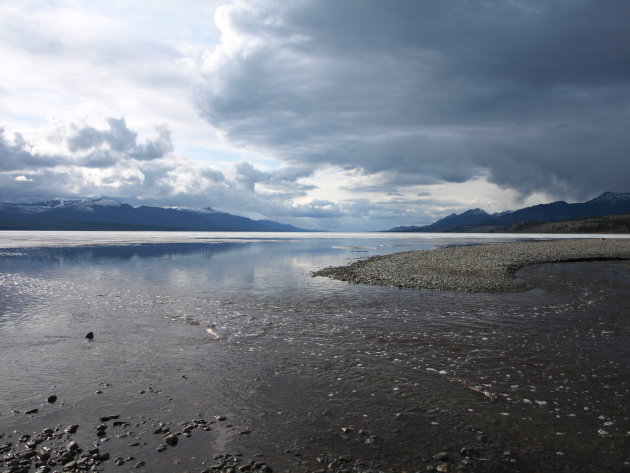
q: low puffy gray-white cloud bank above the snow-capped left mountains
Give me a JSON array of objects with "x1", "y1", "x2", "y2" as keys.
[{"x1": 0, "y1": 118, "x2": 341, "y2": 226}]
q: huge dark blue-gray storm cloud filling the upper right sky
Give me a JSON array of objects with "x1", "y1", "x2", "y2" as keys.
[{"x1": 196, "y1": 0, "x2": 630, "y2": 198}]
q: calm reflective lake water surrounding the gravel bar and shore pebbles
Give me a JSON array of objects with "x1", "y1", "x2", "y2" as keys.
[{"x1": 0, "y1": 232, "x2": 630, "y2": 472}]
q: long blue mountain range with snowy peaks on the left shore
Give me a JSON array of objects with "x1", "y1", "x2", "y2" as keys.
[{"x1": 0, "y1": 199, "x2": 304, "y2": 232}]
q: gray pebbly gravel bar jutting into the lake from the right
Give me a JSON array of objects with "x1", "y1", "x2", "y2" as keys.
[{"x1": 312, "y1": 239, "x2": 630, "y2": 292}]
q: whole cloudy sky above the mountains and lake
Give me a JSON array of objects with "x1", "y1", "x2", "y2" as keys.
[{"x1": 0, "y1": 0, "x2": 630, "y2": 231}]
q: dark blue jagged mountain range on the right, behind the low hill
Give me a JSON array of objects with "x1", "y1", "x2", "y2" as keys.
[{"x1": 388, "y1": 192, "x2": 630, "y2": 233}]
